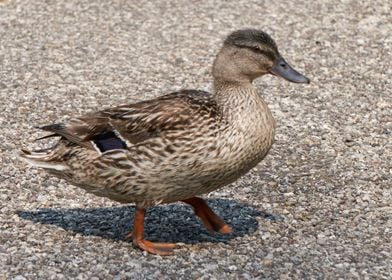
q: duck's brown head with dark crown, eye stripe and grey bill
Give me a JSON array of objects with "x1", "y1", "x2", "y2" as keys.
[{"x1": 213, "y1": 29, "x2": 310, "y2": 83}]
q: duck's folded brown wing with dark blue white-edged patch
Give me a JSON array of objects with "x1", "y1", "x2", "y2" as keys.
[{"x1": 40, "y1": 90, "x2": 219, "y2": 152}]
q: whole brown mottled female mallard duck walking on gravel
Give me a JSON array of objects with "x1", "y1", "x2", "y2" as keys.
[{"x1": 21, "y1": 29, "x2": 309, "y2": 255}]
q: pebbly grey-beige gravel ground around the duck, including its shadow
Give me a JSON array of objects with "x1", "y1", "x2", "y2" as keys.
[{"x1": 0, "y1": 0, "x2": 392, "y2": 280}]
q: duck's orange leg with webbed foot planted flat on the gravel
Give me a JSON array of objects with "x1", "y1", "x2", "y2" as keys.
[{"x1": 128, "y1": 207, "x2": 176, "y2": 255}]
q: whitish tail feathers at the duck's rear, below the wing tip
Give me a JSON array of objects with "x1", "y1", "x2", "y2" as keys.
[{"x1": 18, "y1": 148, "x2": 68, "y2": 171}]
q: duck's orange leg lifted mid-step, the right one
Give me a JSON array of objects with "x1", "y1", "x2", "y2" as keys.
[{"x1": 182, "y1": 197, "x2": 232, "y2": 234}]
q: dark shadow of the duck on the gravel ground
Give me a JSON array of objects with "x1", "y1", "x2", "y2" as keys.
[{"x1": 18, "y1": 199, "x2": 279, "y2": 244}]
